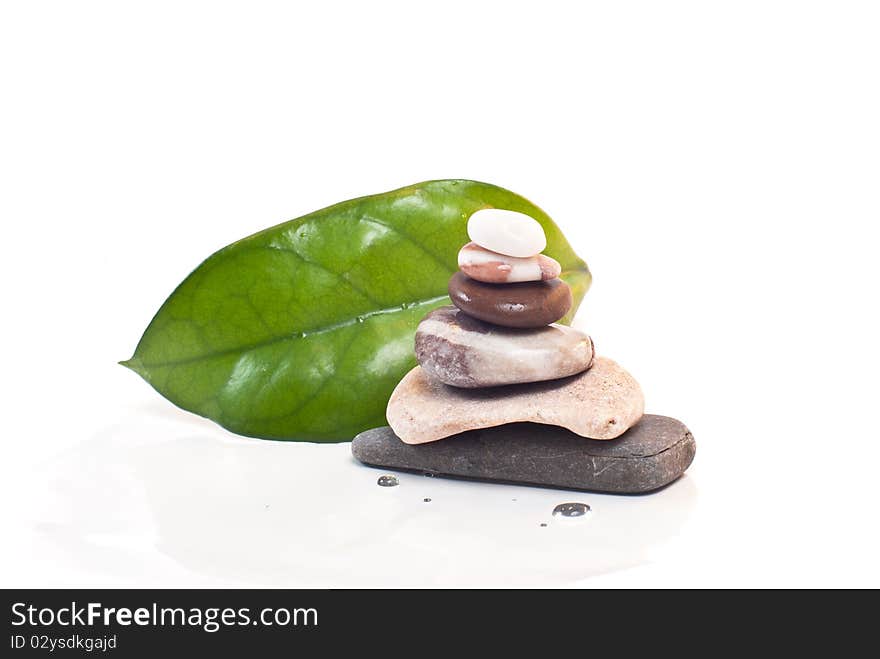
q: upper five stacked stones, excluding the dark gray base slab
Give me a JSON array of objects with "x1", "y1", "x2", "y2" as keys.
[{"x1": 387, "y1": 210, "x2": 644, "y2": 444}]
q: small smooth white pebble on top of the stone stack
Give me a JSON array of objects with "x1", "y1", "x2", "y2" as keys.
[{"x1": 468, "y1": 208, "x2": 547, "y2": 258}]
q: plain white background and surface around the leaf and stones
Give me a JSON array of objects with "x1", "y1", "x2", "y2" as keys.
[{"x1": 0, "y1": 0, "x2": 880, "y2": 587}]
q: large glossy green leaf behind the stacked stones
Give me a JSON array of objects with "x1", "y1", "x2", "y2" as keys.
[{"x1": 123, "y1": 180, "x2": 590, "y2": 442}]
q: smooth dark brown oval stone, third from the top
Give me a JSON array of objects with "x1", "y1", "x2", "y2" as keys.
[{"x1": 449, "y1": 272, "x2": 572, "y2": 328}]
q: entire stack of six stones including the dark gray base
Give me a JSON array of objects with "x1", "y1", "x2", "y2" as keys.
[{"x1": 352, "y1": 209, "x2": 696, "y2": 493}]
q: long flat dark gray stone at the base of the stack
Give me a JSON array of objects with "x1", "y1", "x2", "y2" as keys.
[{"x1": 351, "y1": 414, "x2": 696, "y2": 494}]
